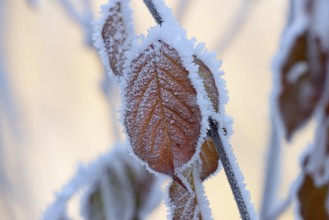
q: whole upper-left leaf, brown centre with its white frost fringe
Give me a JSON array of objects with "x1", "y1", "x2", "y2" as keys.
[{"x1": 94, "y1": 0, "x2": 134, "y2": 76}]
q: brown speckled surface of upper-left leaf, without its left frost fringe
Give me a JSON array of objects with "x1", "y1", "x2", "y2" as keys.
[{"x1": 102, "y1": 1, "x2": 130, "y2": 76}]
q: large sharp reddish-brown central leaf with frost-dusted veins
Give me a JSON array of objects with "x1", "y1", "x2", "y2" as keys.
[{"x1": 124, "y1": 41, "x2": 201, "y2": 176}]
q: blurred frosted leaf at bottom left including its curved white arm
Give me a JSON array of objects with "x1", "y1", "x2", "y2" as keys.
[{"x1": 41, "y1": 144, "x2": 161, "y2": 220}]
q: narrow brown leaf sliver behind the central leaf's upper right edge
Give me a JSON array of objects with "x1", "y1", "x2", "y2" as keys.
[{"x1": 193, "y1": 55, "x2": 219, "y2": 112}]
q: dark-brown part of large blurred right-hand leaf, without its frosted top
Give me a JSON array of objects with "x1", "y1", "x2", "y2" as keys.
[{"x1": 279, "y1": 31, "x2": 327, "y2": 139}]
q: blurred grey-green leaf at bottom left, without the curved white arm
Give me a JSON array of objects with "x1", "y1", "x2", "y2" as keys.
[{"x1": 82, "y1": 146, "x2": 160, "y2": 220}]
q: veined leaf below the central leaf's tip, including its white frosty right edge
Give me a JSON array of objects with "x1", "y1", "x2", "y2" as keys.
[{"x1": 168, "y1": 163, "x2": 212, "y2": 220}]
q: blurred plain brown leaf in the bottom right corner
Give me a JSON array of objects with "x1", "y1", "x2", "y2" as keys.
[{"x1": 298, "y1": 174, "x2": 329, "y2": 220}]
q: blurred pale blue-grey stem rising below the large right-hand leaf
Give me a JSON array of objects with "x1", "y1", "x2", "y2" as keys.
[{"x1": 260, "y1": 119, "x2": 281, "y2": 219}]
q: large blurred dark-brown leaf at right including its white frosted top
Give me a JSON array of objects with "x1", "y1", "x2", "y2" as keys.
[{"x1": 275, "y1": 0, "x2": 329, "y2": 140}]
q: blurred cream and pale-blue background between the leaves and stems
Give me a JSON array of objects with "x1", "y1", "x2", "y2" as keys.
[{"x1": 0, "y1": 0, "x2": 311, "y2": 220}]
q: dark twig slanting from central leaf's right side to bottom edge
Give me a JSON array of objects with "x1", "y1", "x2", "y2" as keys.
[{"x1": 209, "y1": 118, "x2": 250, "y2": 220}]
